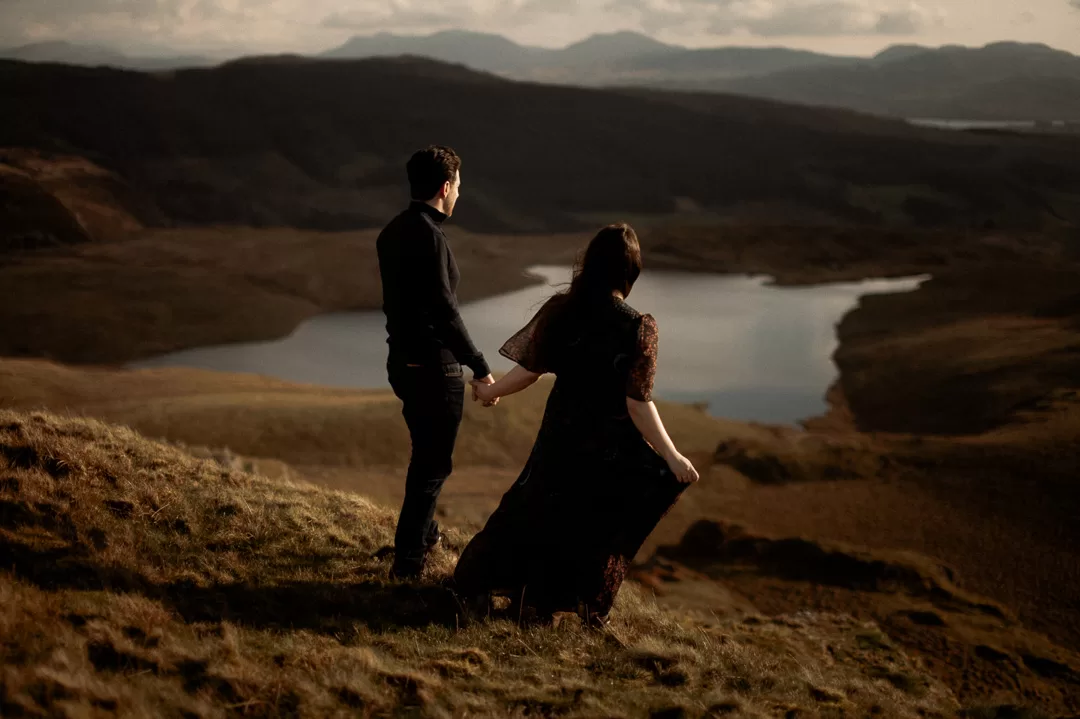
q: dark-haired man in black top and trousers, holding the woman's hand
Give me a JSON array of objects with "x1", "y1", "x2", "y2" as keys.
[{"x1": 378, "y1": 146, "x2": 495, "y2": 578}]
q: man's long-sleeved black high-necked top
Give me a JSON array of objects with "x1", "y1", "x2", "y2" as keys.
[{"x1": 377, "y1": 197, "x2": 491, "y2": 377}]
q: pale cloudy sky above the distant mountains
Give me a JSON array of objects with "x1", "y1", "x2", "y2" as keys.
[{"x1": 6, "y1": 0, "x2": 1080, "y2": 55}]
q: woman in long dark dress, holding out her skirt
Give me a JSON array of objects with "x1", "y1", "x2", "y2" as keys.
[{"x1": 455, "y1": 225, "x2": 698, "y2": 621}]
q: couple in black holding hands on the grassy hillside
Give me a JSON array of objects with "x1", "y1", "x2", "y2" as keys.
[{"x1": 378, "y1": 146, "x2": 698, "y2": 619}]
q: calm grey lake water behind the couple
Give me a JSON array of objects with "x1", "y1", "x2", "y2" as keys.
[{"x1": 131, "y1": 267, "x2": 921, "y2": 422}]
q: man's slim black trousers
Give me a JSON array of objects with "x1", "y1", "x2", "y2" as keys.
[{"x1": 388, "y1": 361, "x2": 465, "y2": 575}]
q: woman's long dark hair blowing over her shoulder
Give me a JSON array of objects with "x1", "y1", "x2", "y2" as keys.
[{"x1": 532, "y1": 222, "x2": 642, "y2": 350}]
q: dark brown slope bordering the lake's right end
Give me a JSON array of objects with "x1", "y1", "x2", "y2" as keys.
[{"x1": 834, "y1": 262, "x2": 1080, "y2": 431}]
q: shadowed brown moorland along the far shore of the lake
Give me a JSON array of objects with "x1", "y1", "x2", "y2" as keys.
[{"x1": 0, "y1": 225, "x2": 1076, "y2": 366}]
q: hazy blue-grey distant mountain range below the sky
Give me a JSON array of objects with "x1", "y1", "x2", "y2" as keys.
[{"x1": 6, "y1": 30, "x2": 1080, "y2": 121}]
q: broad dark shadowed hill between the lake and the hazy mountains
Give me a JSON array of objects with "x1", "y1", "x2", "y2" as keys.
[{"x1": 0, "y1": 58, "x2": 1080, "y2": 239}]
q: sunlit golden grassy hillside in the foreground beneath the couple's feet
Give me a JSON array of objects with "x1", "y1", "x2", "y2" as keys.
[{"x1": 0, "y1": 410, "x2": 956, "y2": 717}]
